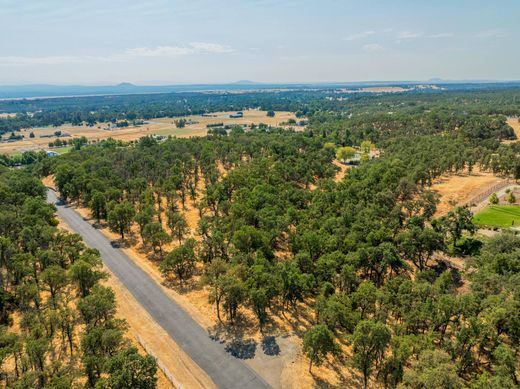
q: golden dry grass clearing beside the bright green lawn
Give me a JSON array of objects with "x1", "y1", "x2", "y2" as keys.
[{"x1": 431, "y1": 169, "x2": 506, "y2": 216}]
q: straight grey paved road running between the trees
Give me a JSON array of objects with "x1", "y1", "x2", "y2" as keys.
[{"x1": 47, "y1": 189, "x2": 269, "y2": 389}]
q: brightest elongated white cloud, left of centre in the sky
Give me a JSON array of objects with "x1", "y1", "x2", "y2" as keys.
[{"x1": 125, "y1": 42, "x2": 234, "y2": 57}]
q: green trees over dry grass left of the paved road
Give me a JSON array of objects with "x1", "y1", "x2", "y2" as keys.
[{"x1": 0, "y1": 168, "x2": 157, "y2": 388}]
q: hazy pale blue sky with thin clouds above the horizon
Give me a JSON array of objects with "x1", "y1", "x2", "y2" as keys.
[{"x1": 0, "y1": 0, "x2": 520, "y2": 84}]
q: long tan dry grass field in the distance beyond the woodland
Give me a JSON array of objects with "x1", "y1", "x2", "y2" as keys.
[{"x1": 0, "y1": 109, "x2": 296, "y2": 154}]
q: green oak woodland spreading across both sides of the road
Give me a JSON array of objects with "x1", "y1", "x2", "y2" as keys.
[{"x1": 0, "y1": 86, "x2": 520, "y2": 389}]
